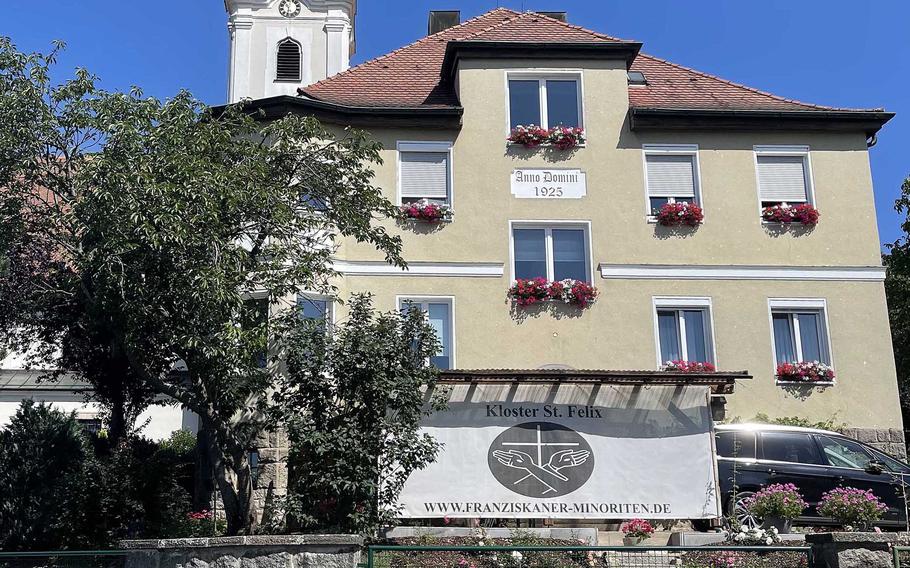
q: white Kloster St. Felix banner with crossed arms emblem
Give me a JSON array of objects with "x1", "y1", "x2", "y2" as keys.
[{"x1": 400, "y1": 384, "x2": 720, "y2": 519}]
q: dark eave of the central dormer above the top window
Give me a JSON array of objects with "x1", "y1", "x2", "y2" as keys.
[{"x1": 440, "y1": 40, "x2": 642, "y2": 81}]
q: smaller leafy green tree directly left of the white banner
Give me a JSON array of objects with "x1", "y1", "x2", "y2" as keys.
[{"x1": 275, "y1": 296, "x2": 445, "y2": 534}]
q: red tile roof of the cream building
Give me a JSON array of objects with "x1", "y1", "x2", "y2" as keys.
[{"x1": 300, "y1": 8, "x2": 880, "y2": 111}]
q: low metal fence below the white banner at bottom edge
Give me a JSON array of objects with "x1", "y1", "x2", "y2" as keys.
[{"x1": 364, "y1": 545, "x2": 812, "y2": 568}]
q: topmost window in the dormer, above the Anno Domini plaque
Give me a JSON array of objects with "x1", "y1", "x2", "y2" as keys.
[{"x1": 509, "y1": 75, "x2": 582, "y2": 129}]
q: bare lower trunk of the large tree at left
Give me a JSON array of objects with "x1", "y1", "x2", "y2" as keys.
[{"x1": 200, "y1": 418, "x2": 257, "y2": 536}]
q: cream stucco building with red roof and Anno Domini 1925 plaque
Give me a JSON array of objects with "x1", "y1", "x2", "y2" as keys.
[{"x1": 235, "y1": 2, "x2": 903, "y2": 452}]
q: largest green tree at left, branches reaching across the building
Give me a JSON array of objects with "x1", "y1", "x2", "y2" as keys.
[{"x1": 0, "y1": 40, "x2": 404, "y2": 534}]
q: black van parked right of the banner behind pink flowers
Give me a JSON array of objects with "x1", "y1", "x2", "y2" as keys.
[{"x1": 715, "y1": 424, "x2": 910, "y2": 530}]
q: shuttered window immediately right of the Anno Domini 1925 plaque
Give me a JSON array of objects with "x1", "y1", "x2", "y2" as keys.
[{"x1": 644, "y1": 145, "x2": 699, "y2": 215}]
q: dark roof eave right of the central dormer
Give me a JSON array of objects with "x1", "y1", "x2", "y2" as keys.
[{"x1": 629, "y1": 107, "x2": 894, "y2": 136}]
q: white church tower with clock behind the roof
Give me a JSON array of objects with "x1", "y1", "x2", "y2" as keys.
[{"x1": 224, "y1": 0, "x2": 357, "y2": 102}]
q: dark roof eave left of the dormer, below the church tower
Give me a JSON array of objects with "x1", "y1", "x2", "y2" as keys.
[{"x1": 213, "y1": 95, "x2": 464, "y2": 128}]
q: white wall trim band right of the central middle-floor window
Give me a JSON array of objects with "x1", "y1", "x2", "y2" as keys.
[{"x1": 599, "y1": 263, "x2": 885, "y2": 282}]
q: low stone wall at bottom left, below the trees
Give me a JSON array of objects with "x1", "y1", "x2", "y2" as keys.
[{"x1": 120, "y1": 535, "x2": 363, "y2": 568}]
